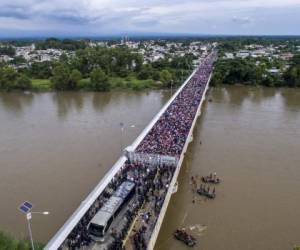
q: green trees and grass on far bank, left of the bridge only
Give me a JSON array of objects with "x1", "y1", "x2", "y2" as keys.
[{"x1": 0, "y1": 45, "x2": 194, "y2": 91}]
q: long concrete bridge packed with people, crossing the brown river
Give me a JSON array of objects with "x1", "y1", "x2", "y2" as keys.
[{"x1": 45, "y1": 51, "x2": 216, "y2": 250}]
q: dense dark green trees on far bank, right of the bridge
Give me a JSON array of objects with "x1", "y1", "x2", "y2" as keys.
[{"x1": 212, "y1": 55, "x2": 300, "y2": 87}]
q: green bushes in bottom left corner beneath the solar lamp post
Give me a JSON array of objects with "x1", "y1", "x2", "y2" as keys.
[{"x1": 0, "y1": 231, "x2": 43, "y2": 250}]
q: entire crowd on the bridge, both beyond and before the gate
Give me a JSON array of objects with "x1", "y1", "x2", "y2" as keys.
[{"x1": 61, "y1": 53, "x2": 215, "y2": 250}]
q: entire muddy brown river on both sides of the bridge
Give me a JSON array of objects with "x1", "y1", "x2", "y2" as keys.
[{"x1": 0, "y1": 86, "x2": 300, "y2": 250}]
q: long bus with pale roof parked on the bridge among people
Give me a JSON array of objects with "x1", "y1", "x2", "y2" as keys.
[{"x1": 88, "y1": 181, "x2": 135, "y2": 242}]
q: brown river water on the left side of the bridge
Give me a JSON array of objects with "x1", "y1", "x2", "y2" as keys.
[{"x1": 0, "y1": 91, "x2": 170, "y2": 242}]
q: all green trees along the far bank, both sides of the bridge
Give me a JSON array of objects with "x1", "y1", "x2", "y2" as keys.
[{"x1": 0, "y1": 37, "x2": 300, "y2": 91}]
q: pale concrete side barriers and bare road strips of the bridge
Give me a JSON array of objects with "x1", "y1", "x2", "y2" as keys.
[{"x1": 45, "y1": 51, "x2": 214, "y2": 250}]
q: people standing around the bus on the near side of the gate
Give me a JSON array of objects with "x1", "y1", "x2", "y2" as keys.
[{"x1": 61, "y1": 158, "x2": 174, "y2": 250}]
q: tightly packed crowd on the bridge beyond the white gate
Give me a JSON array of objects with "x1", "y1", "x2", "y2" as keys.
[{"x1": 137, "y1": 55, "x2": 214, "y2": 157}]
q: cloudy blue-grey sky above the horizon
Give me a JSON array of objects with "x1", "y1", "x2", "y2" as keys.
[{"x1": 0, "y1": 0, "x2": 300, "y2": 37}]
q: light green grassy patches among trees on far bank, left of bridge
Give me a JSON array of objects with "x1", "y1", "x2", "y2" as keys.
[{"x1": 31, "y1": 76, "x2": 161, "y2": 91}]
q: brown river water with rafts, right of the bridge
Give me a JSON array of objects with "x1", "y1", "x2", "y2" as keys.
[{"x1": 155, "y1": 86, "x2": 300, "y2": 250}]
